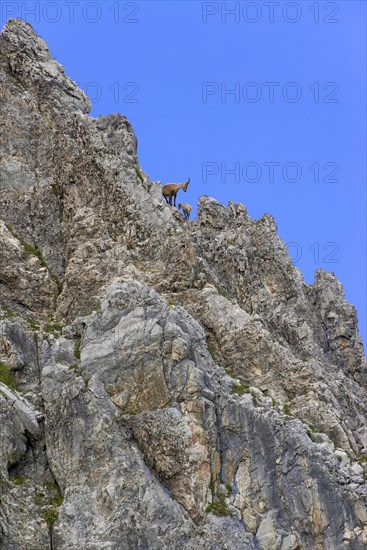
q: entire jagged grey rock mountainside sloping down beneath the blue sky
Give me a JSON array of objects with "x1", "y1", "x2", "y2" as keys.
[{"x1": 0, "y1": 20, "x2": 367, "y2": 550}]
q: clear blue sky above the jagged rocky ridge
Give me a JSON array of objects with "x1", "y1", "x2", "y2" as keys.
[{"x1": 1, "y1": 0, "x2": 367, "y2": 342}]
